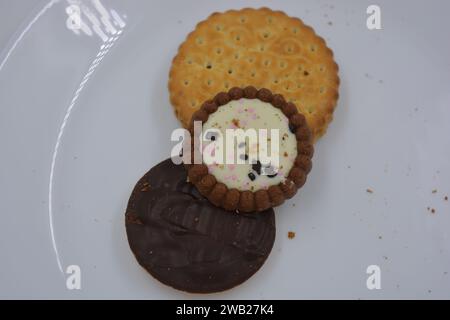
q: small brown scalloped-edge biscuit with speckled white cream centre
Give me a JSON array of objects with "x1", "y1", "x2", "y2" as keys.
[{"x1": 187, "y1": 86, "x2": 314, "y2": 212}]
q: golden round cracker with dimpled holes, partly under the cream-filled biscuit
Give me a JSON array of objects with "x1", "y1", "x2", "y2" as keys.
[{"x1": 169, "y1": 8, "x2": 339, "y2": 139}]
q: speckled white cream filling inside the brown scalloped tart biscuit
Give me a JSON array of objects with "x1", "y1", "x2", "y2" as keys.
[{"x1": 203, "y1": 99, "x2": 297, "y2": 191}]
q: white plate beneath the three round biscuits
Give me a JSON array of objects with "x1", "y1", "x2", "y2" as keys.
[{"x1": 0, "y1": 0, "x2": 450, "y2": 299}]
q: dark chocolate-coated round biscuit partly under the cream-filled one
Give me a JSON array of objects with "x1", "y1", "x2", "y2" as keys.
[{"x1": 125, "y1": 159, "x2": 275, "y2": 293}]
